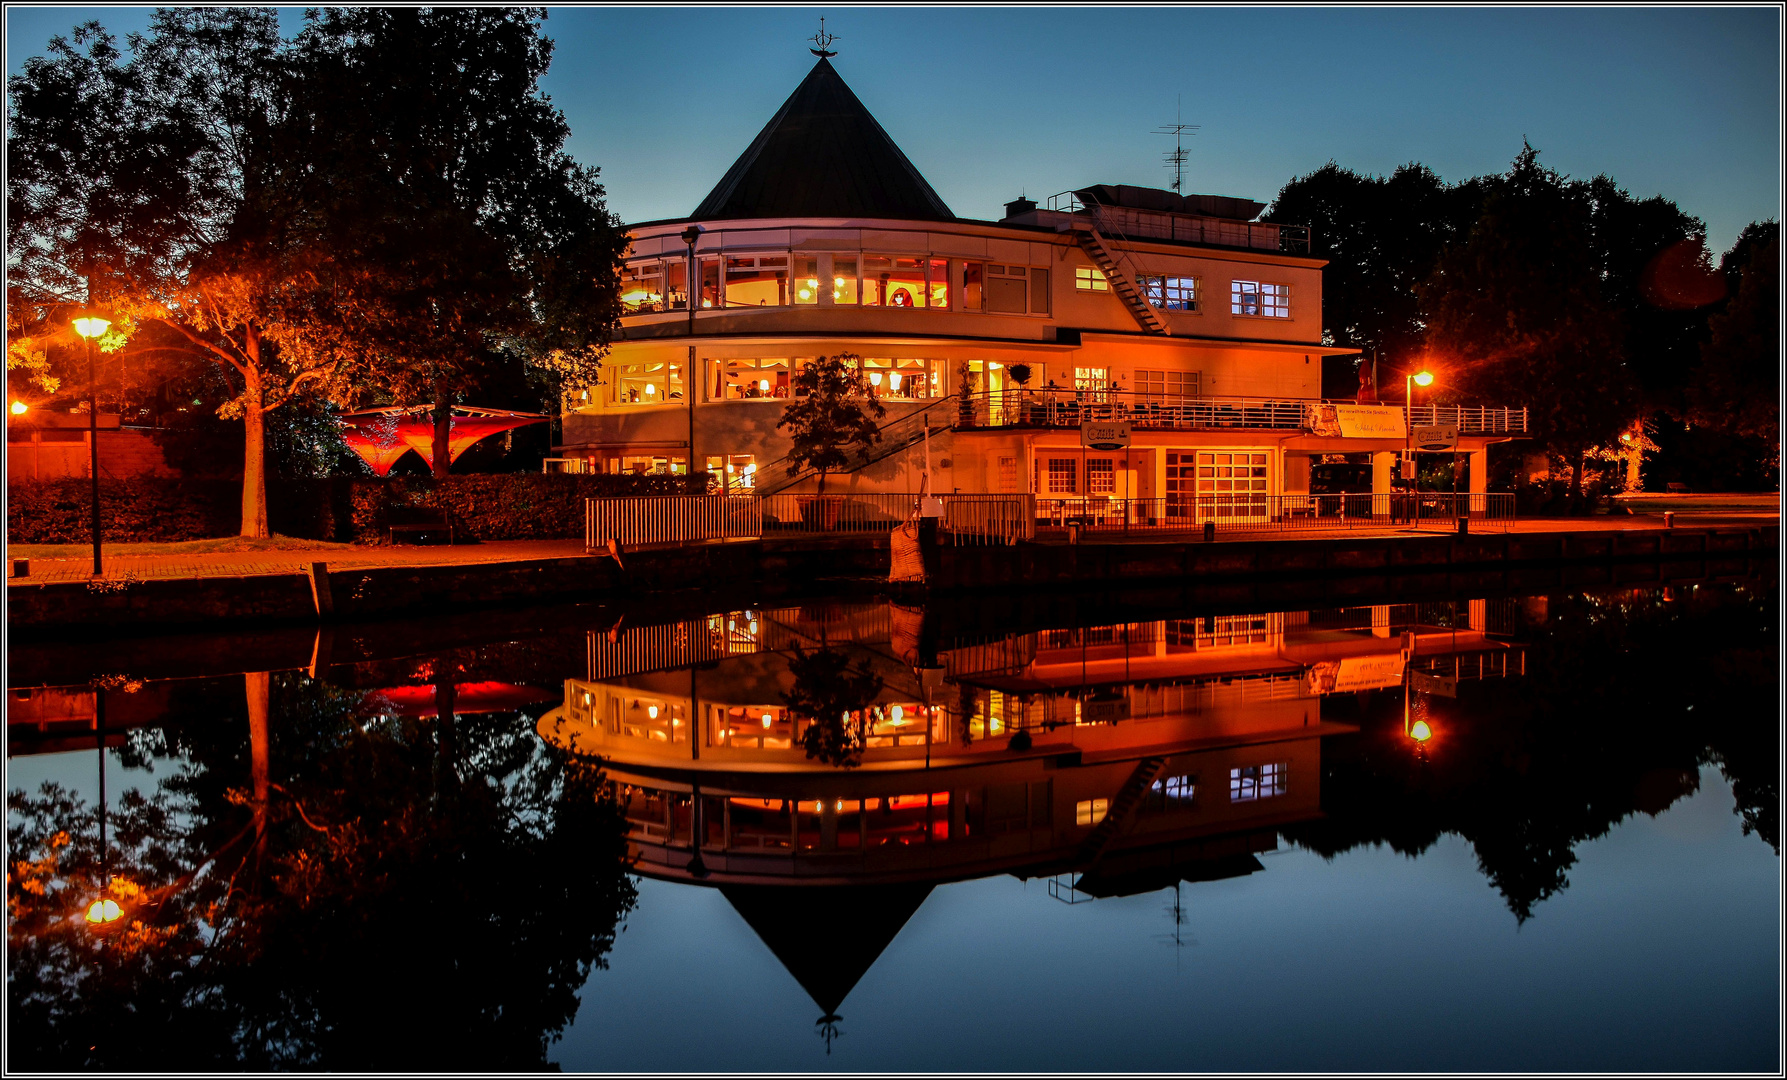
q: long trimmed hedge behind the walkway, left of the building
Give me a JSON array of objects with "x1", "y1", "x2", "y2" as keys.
[{"x1": 7, "y1": 472, "x2": 706, "y2": 544}]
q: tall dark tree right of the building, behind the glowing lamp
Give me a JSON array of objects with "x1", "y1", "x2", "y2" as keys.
[{"x1": 1417, "y1": 145, "x2": 1637, "y2": 497}]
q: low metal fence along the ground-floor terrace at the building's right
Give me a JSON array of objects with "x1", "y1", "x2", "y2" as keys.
[{"x1": 1036, "y1": 492, "x2": 1514, "y2": 535}]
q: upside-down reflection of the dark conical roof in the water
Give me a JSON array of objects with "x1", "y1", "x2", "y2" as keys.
[{"x1": 720, "y1": 883, "x2": 931, "y2": 1016}]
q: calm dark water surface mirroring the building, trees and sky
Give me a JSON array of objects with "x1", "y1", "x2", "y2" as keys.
[{"x1": 7, "y1": 578, "x2": 1782, "y2": 1071}]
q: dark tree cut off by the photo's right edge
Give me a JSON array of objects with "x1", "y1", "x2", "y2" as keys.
[{"x1": 1689, "y1": 222, "x2": 1782, "y2": 447}]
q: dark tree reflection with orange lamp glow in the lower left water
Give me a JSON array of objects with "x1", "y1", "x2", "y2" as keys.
[{"x1": 7, "y1": 674, "x2": 634, "y2": 1071}]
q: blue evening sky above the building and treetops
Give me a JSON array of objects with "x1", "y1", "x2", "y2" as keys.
[{"x1": 7, "y1": 7, "x2": 1782, "y2": 250}]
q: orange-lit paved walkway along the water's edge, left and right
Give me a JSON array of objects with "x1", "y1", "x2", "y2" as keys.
[{"x1": 11, "y1": 504, "x2": 1780, "y2": 585}]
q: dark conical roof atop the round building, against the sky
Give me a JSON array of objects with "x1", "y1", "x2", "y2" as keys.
[{"x1": 692, "y1": 57, "x2": 956, "y2": 222}]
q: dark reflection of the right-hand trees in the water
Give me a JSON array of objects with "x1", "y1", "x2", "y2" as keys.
[{"x1": 1283, "y1": 586, "x2": 1780, "y2": 923}]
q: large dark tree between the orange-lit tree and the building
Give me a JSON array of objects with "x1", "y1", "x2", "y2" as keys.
[{"x1": 282, "y1": 9, "x2": 627, "y2": 476}]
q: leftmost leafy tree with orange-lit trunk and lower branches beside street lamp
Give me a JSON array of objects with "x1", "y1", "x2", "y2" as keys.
[{"x1": 7, "y1": 9, "x2": 350, "y2": 536}]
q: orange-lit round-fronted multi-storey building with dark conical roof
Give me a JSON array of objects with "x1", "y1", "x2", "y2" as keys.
[{"x1": 561, "y1": 59, "x2": 1526, "y2": 504}]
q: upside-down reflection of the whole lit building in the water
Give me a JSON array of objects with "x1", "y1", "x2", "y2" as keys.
[{"x1": 538, "y1": 601, "x2": 1526, "y2": 1032}]
